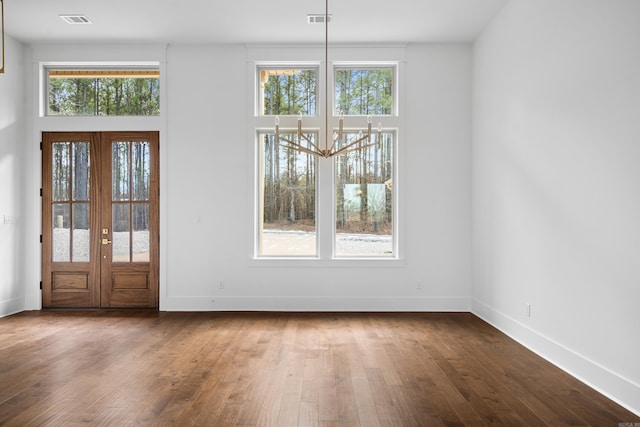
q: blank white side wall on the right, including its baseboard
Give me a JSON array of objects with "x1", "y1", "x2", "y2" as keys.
[{"x1": 472, "y1": 0, "x2": 640, "y2": 413}]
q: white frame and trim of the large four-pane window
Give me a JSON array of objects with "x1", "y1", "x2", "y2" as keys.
[{"x1": 248, "y1": 47, "x2": 404, "y2": 267}]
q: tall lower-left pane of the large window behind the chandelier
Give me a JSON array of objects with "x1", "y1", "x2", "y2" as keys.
[{"x1": 258, "y1": 134, "x2": 317, "y2": 256}]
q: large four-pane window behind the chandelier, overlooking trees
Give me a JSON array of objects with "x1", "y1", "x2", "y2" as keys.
[{"x1": 255, "y1": 64, "x2": 397, "y2": 259}]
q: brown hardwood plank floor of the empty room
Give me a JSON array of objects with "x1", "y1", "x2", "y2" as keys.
[{"x1": 0, "y1": 311, "x2": 640, "y2": 427}]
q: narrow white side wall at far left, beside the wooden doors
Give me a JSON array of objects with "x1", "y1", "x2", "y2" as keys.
[{"x1": 0, "y1": 37, "x2": 25, "y2": 317}]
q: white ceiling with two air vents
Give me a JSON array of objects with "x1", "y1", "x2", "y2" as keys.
[{"x1": 4, "y1": 0, "x2": 508, "y2": 43}]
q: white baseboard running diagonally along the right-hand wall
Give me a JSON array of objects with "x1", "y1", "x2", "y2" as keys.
[{"x1": 471, "y1": 299, "x2": 640, "y2": 421}]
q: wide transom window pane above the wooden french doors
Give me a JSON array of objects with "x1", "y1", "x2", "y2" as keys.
[{"x1": 47, "y1": 70, "x2": 160, "y2": 116}]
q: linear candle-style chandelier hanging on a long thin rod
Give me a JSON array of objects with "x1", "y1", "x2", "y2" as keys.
[{"x1": 275, "y1": 0, "x2": 382, "y2": 158}]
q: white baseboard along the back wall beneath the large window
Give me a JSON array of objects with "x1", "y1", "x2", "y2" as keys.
[{"x1": 161, "y1": 296, "x2": 470, "y2": 312}]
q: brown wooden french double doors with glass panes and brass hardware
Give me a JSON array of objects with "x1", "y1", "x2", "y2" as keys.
[{"x1": 42, "y1": 132, "x2": 159, "y2": 308}]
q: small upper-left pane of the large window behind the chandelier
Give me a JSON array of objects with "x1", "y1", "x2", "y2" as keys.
[{"x1": 258, "y1": 68, "x2": 318, "y2": 116}]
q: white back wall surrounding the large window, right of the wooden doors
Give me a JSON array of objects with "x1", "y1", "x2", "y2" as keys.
[{"x1": 161, "y1": 45, "x2": 471, "y2": 310}]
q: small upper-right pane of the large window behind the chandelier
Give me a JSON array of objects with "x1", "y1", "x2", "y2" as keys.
[{"x1": 335, "y1": 68, "x2": 394, "y2": 116}]
